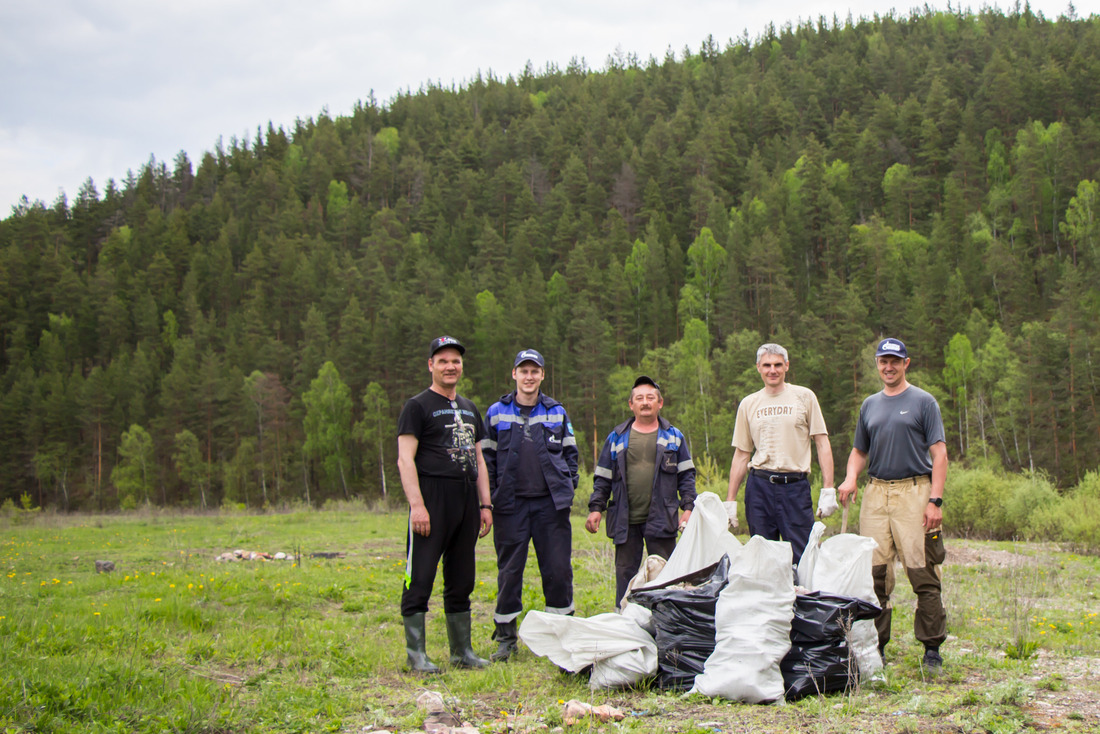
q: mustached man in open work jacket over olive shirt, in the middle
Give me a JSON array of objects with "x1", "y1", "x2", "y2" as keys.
[{"x1": 584, "y1": 375, "x2": 695, "y2": 607}]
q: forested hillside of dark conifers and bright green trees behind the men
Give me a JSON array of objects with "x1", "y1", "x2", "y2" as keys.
[{"x1": 0, "y1": 8, "x2": 1100, "y2": 508}]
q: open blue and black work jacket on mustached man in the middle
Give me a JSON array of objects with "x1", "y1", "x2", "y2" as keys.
[{"x1": 589, "y1": 416, "x2": 695, "y2": 545}]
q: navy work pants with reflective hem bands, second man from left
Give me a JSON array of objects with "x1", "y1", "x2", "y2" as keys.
[{"x1": 493, "y1": 495, "x2": 573, "y2": 623}]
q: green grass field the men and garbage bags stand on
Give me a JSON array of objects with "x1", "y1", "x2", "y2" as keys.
[{"x1": 0, "y1": 505, "x2": 1100, "y2": 733}]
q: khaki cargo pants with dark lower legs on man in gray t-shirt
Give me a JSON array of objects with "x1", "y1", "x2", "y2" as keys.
[{"x1": 859, "y1": 476, "x2": 947, "y2": 649}]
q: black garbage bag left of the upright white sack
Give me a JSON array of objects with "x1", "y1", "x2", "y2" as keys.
[{"x1": 630, "y1": 556, "x2": 729, "y2": 690}]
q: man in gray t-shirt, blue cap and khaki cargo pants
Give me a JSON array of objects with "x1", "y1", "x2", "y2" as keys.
[{"x1": 837, "y1": 339, "x2": 947, "y2": 672}]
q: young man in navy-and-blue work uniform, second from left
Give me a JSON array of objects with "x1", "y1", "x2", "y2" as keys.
[{"x1": 482, "y1": 349, "x2": 578, "y2": 660}]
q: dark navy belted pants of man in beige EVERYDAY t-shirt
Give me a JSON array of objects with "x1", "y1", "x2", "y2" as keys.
[{"x1": 745, "y1": 472, "x2": 814, "y2": 563}]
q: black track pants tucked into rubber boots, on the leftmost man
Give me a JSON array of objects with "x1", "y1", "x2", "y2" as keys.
[{"x1": 402, "y1": 476, "x2": 481, "y2": 616}]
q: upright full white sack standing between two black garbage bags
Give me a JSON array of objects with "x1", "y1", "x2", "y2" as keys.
[{"x1": 690, "y1": 536, "x2": 794, "y2": 703}]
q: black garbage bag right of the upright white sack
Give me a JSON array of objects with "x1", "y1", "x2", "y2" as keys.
[{"x1": 779, "y1": 591, "x2": 879, "y2": 701}]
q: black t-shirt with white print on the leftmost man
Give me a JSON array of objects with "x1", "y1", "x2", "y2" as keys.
[{"x1": 397, "y1": 390, "x2": 485, "y2": 479}]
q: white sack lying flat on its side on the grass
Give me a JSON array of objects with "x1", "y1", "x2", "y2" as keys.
[{"x1": 519, "y1": 611, "x2": 657, "y2": 690}]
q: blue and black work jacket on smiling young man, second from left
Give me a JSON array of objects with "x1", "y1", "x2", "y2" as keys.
[{"x1": 482, "y1": 392, "x2": 579, "y2": 514}]
